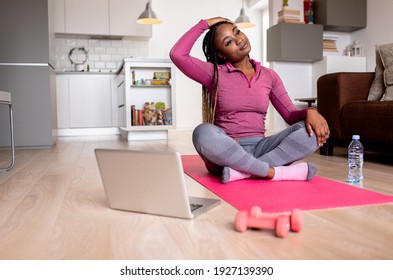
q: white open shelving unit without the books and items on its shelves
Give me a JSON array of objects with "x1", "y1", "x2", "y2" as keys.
[{"x1": 119, "y1": 58, "x2": 176, "y2": 141}]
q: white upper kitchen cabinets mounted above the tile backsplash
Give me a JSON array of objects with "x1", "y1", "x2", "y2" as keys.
[{"x1": 55, "y1": 0, "x2": 152, "y2": 37}]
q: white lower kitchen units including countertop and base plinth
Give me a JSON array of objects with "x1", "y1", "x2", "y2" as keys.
[{"x1": 56, "y1": 71, "x2": 119, "y2": 136}]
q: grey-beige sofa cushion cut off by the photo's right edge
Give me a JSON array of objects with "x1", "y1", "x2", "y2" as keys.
[{"x1": 379, "y1": 44, "x2": 393, "y2": 101}]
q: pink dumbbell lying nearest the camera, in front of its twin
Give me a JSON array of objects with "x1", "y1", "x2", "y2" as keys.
[{"x1": 235, "y1": 211, "x2": 290, "y2": 238}]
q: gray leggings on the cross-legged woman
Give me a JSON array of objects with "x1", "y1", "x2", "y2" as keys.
[{"x1": 192, "y1": 121, "x2": 319, "y2": 177}]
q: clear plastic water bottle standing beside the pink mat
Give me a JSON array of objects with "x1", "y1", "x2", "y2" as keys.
[{"x1": 348, "y1": 135, "x2": 364, "y2": 184}]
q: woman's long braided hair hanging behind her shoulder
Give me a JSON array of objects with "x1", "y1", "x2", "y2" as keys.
[{"x1": 202, "y1": 21, "x2": 231, "y2": 123}]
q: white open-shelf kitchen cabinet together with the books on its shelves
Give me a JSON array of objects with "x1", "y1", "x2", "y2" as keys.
[{"x1": 118, "y1": 58, "x2": 176, "y2": 140}]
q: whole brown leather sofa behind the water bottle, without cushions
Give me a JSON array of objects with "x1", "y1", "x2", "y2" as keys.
[{"x1": 317, "y1": 72, "x2": 393, "y2": 155}]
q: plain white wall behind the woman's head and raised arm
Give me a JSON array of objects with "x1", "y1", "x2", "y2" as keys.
[{"x1": 149, "y1": 0, "x2": 262, "y2": 130}]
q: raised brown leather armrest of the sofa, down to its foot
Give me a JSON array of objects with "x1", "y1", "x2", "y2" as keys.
[{"x1": 317, "y1": 72, "x2": 374, "y2": 139}]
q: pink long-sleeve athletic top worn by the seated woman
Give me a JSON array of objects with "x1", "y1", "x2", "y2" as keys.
[{"x1": 170, "y1": 20, "x2": 307, "y2": 139}]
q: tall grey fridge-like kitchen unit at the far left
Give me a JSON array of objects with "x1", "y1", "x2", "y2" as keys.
[{"x1": 0, "y1": 0, "x2": 57, "y2": 147}]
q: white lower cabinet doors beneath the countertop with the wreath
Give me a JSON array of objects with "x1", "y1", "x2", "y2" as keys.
[{"x1": 57, "y1": 73, "x2": 117, "y2": 128}]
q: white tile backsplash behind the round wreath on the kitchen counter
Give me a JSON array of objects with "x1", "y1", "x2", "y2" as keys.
[{"x1": 55, "y1": 38, "x2": 149, "y2": 72}]
